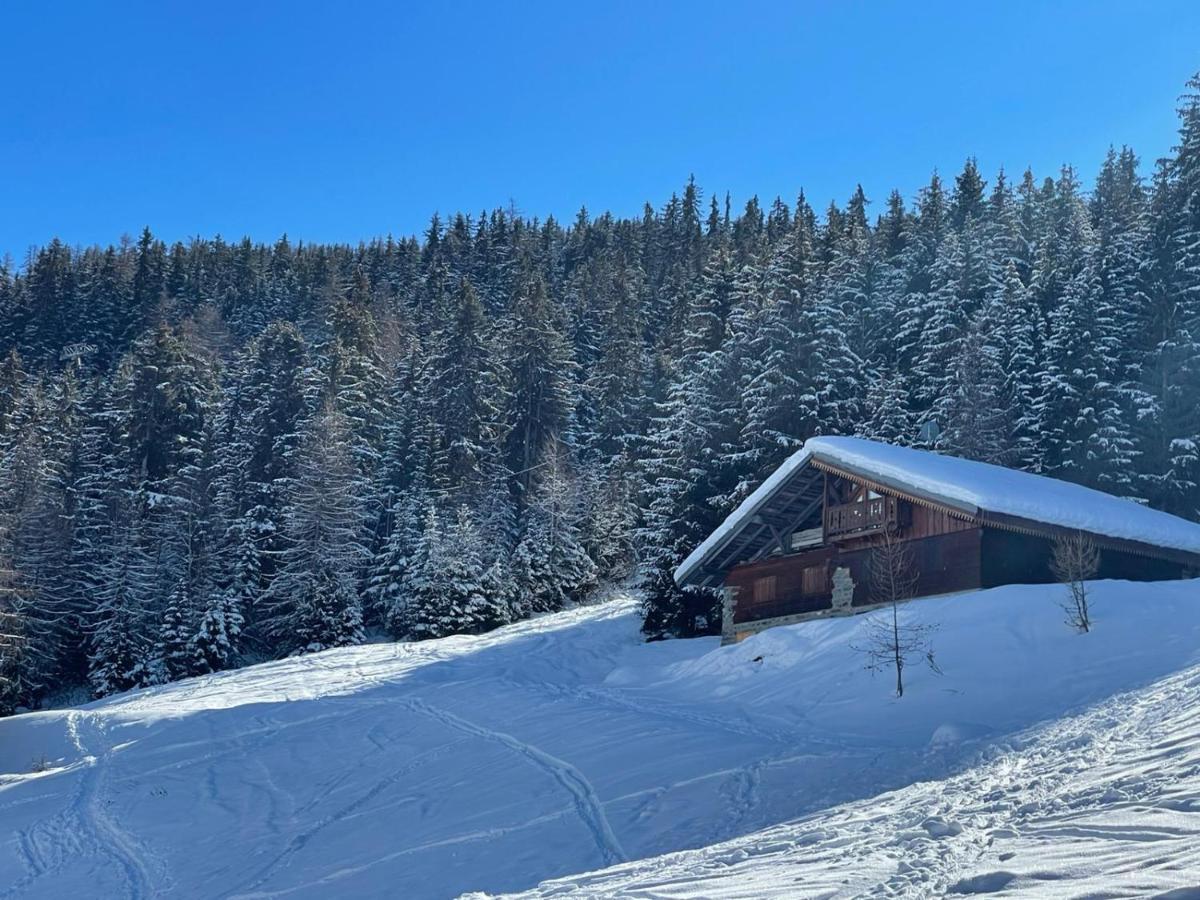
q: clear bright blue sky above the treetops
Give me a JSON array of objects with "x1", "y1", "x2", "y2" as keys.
[{"x1": 0, "y1": 0, "x2": 1200, "y2": 262}]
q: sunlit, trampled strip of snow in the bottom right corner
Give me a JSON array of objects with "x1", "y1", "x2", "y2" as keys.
[{"x1": 505, "y1": 668, "x2": 1200, "y2": 900}]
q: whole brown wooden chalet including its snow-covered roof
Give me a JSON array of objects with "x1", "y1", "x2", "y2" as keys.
[{"x1": 674, "y1": 438, "x2": 1200, "y2": 642}]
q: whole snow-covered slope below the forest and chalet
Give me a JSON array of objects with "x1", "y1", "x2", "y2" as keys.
[{"x1": 0, "y1": 582, "x2": 1200, "y2": 899}]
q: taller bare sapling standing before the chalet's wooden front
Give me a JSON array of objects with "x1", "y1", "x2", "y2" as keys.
[{"x1": 854, "y1": 528, "x2": 942, "y2": 697}]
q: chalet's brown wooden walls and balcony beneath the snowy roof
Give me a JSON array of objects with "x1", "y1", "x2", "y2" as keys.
[{"x1": 689, "y1": 460, "x2": 1200, "y2": 642}]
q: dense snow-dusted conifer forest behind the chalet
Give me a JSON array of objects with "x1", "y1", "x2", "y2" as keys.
[{"x1": 0, "y1": 79, "x2": 1200, "y2": 712}]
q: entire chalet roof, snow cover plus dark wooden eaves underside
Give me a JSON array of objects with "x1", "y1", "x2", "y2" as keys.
[{"x1": 674, "y1": 438, "x2": 1200, "y2": 584}]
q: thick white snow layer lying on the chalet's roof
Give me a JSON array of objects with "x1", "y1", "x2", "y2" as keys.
[{"x1": 674, "y1": 437, "x2": 1200, "y2": 584}]
